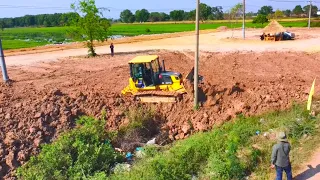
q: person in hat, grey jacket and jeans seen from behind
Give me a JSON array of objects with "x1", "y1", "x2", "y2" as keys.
[{"x1": 271, "y1": 132, "x2": 292, "y2": 180}]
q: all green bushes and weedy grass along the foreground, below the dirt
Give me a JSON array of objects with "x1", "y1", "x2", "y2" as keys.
[{"x1": 18, "y1": 102, "x2": 320, "y2": 180}]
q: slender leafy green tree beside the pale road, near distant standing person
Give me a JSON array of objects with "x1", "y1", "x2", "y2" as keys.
[{"x1": 71, "y1": 0, "x2": 110, "y2": 56}]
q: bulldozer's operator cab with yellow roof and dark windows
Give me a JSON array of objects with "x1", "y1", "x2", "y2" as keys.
[{"x1": 129, "y1": 55, "x2": 162, "y2": 88}]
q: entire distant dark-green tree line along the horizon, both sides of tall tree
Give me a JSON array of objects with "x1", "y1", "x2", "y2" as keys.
[{"x1": 0, "y1": 3, "x2": 319, "y2": 28}]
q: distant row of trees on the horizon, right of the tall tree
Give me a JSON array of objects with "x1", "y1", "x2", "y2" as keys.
[{"x1": 120, "y1": 3, "x2": 319, "y2": 23}]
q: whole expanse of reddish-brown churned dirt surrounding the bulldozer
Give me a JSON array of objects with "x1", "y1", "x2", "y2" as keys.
[{"x1": 0, "y1": 51, "x2": 320, "y2": 178}]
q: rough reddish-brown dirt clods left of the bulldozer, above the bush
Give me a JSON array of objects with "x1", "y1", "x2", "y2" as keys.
[{"x1": 0, "y1": 87, "x2": 131, "y2": 178}]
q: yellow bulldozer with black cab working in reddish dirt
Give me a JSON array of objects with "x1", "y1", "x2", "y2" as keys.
[{"x1": 121, "y1": 55, "x2": 199, "y2": 103}]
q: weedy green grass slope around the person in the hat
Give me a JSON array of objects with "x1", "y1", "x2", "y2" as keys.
[{"x1": 110, "y1": 106, "x2": 319, "y2": 180}]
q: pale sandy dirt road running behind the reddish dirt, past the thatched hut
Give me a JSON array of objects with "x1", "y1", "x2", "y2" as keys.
[{"x1": 6, "y1": 28, "x2": 320, "y2": 66}]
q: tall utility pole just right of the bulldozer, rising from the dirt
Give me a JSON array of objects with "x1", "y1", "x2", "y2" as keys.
[{"x1": 193, "y1": 0, "x2": 200, "y2": 108}]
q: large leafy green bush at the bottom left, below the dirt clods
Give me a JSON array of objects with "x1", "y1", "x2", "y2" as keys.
[{"x1": 17, "y1": 117, "x2": 122, "y2": 179}]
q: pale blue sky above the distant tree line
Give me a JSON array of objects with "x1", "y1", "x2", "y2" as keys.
[{"x1": 0, "y1": 0, "x2": 320, "y2": 19}]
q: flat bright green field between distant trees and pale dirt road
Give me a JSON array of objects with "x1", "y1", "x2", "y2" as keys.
[{"x1": 0, "y1": 20, "x2": 307, "y2": 49}]
